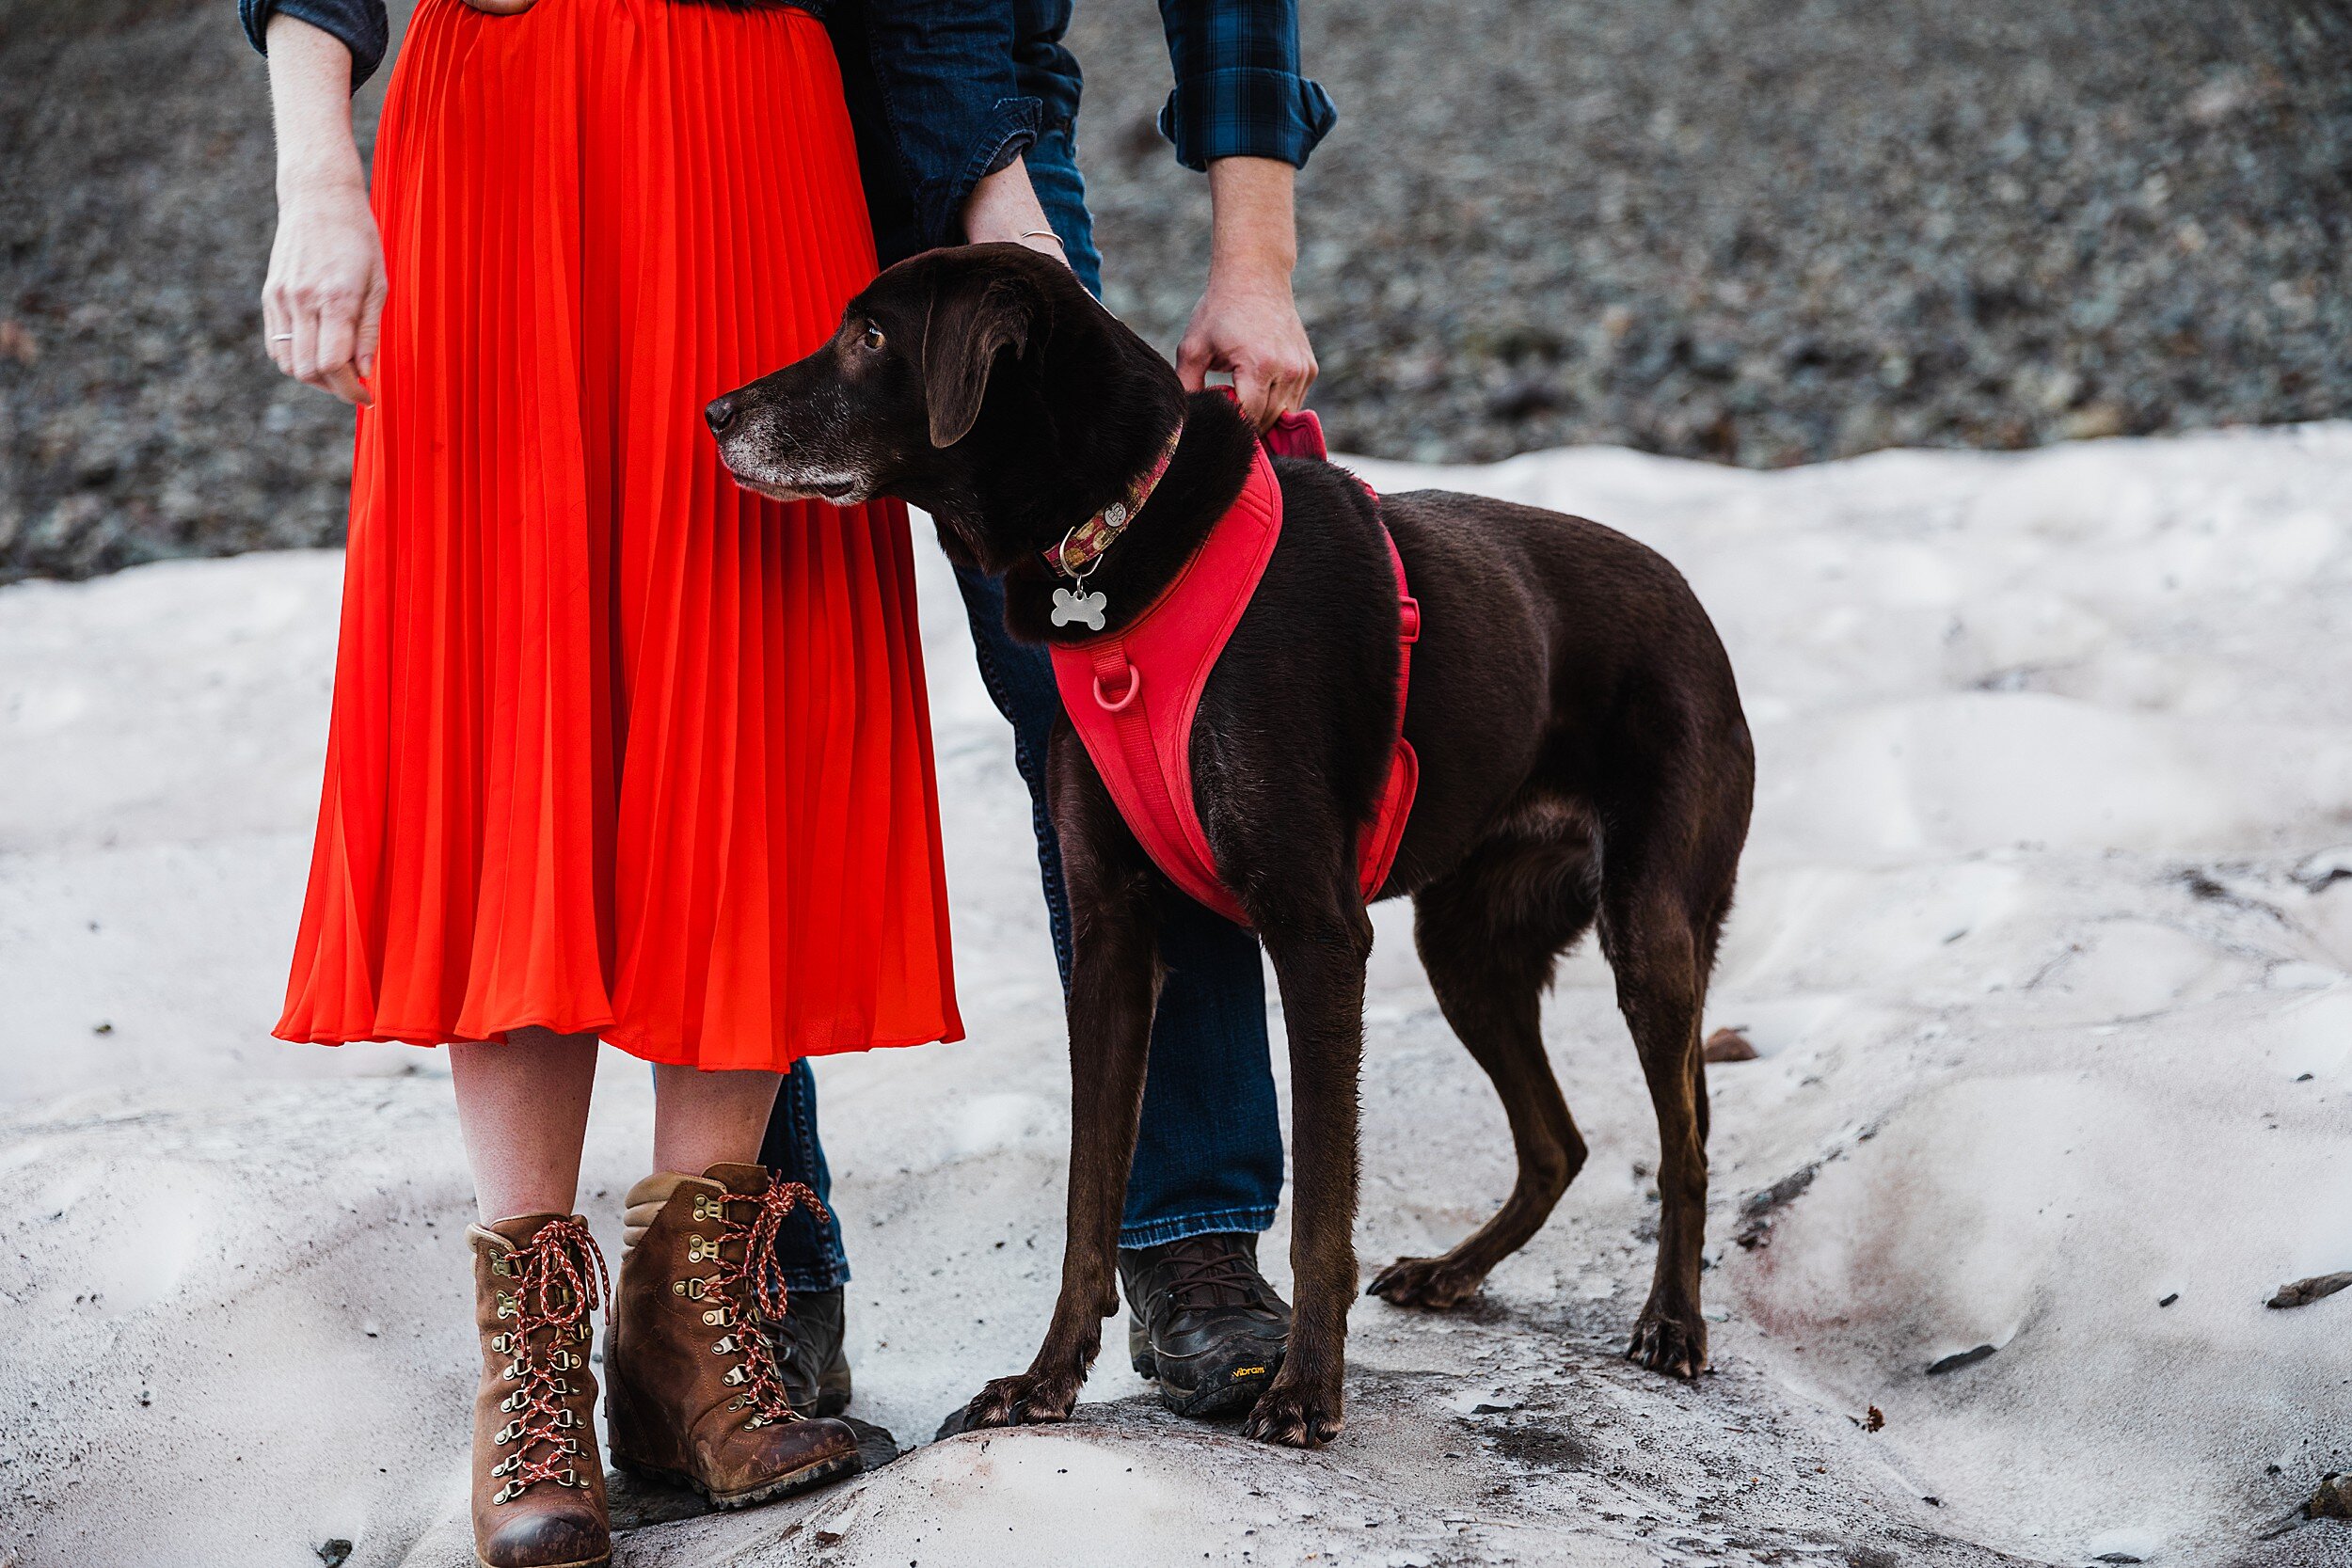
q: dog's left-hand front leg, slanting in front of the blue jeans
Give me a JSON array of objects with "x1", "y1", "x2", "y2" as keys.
[{"x1": 962, "y1": 747, "x2": 1157, "y2": 1430}]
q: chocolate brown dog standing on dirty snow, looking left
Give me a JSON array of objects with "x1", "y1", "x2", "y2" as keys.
[{"x1": 708, "y1": 245, "x2": 1755, "y2": 1449}]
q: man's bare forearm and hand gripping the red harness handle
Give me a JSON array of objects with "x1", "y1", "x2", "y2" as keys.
[{"x1": 1176, "y1": 157, "x2": 1317, "y2": 430}]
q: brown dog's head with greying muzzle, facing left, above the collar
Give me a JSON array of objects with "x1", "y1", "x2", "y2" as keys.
[{"x1": 704, "y1": 245, "x2": 1184, "y2": 571}]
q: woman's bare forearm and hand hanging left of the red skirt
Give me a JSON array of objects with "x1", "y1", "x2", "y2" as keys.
[{"x1": 262, "y1": 11, "x2": 384, "y2": 404}]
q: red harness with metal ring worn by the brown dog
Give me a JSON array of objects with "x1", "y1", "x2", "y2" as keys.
[{"x1": 1054, "y1": 414, "x2": 1421, "y2": 927}]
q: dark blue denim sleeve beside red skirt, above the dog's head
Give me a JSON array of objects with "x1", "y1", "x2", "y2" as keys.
[{"x1": 864, "y1": 0, "x2": 1042, "y2": 246}]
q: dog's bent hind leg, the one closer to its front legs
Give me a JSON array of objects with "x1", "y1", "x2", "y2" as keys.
[{"x1": 1367, "y1": 839, "x2": 1593, "y2": 1307}]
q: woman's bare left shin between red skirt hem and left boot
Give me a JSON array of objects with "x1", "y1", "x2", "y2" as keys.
[{"x1": 450, "y1": 1030, "x2": 596, "y2": 1225}]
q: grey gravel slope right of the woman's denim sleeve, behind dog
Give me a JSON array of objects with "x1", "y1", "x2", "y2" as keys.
[{"x1": 1075, "y1": 0, "x2": 2352, "y2": 466}]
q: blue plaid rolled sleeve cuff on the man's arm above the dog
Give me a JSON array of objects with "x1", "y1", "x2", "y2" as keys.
[{"x1": 1160, "y1": 0, "x2": 1339, "y2": 169}]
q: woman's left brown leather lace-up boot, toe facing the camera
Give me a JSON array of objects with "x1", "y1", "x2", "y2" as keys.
[{"x1": 466, "y1": 1213, "x2": 612, "y2": 1568}]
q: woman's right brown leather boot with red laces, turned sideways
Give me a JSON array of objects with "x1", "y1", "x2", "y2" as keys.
[{"x1": 605, "y1": 1166, "x2": 864, "y2": 1510}]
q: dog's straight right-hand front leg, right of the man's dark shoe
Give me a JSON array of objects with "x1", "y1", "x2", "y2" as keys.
[{"x1": 1242, "y1": 886, "x2": 1372, "y2": 1449}]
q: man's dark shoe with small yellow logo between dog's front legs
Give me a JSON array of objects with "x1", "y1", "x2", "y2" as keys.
[{"x1": 1120, "y1": 1232, "x2": 1292, "y2": 1416}]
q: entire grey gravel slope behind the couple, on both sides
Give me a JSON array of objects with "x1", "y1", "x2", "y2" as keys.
[{"x1": 0, "y1": 0, "x2": 2352, "y2": 580}]
